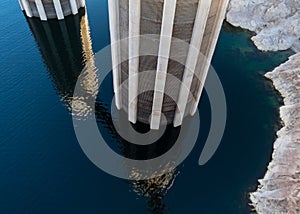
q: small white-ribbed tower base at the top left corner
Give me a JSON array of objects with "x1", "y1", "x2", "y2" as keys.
[{"x1": 18, "y1": 0, "x2": 85, "y2": 21}]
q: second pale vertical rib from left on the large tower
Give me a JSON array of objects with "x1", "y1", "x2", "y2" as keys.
[{"x1": 128, "y1": 0, "x2": 141, "y2": 123}]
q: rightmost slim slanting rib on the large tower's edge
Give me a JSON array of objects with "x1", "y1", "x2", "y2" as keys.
[{"x1": 190, "y1": 0, "x2": 229, "y2": 115}]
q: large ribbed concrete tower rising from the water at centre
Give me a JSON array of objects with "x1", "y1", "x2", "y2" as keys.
[{"x1": 109, "y1": 0, "x2": 228, "y2": 129}]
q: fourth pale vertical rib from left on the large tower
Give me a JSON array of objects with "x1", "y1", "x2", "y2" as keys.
[{"x1": 174, "y1": 0, "x2": 212, "y2": 127}]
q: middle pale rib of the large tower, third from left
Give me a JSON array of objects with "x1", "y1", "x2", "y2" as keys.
[{"x1": 150, "y1": 0, "x2": 177, "y2": 129}]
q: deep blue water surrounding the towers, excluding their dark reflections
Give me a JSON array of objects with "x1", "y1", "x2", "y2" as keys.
[{"x1": 0, "y1": 0, "x2": 291, "y2": 214}]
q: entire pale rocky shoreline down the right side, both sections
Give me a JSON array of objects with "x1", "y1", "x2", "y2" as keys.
[{"x1": 226, "y1": 0, "x2": 300, "y2": 214}]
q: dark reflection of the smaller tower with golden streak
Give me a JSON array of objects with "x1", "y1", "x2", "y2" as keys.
[{"x1": 27, "y1": 9, "x2": 98, "y2": 111}]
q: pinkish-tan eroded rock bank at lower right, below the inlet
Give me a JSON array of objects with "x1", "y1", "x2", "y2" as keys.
[{"x1": 250, "y1": 53, "x2": 300, "y2": 214}]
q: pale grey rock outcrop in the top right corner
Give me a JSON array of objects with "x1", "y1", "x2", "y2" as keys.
[{"x1": 227, "y1": 0, "x2": 300, "y2": 51}]
